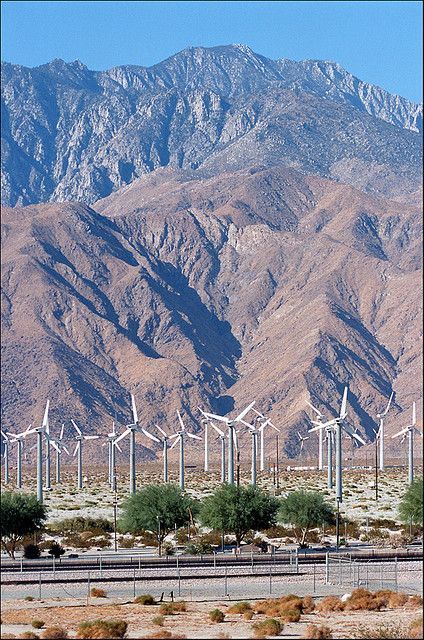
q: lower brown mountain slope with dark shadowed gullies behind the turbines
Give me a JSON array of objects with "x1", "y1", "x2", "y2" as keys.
[{"x1": 2, "y1": 168, "x2": 422, "y2": 460}]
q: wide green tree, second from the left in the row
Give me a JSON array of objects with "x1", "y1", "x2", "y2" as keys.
[{"x1": 119, "y1": 484, "x2": 197, "y2": 552}]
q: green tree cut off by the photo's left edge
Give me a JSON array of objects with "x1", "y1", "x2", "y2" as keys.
[{"x1": 0, "y1": 491, "x2": 47, "y2": 558}]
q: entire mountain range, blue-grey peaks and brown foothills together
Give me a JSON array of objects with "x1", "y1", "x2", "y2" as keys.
[{"x1": 2, "y1": 45, "x2": 422, "y2": 464}]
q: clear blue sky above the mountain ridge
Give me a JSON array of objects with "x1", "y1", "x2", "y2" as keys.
[{"x1": 2, "y1": 0, "x2": 422, "y2": 101}]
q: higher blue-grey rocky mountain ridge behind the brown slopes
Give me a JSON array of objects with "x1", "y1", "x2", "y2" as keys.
[{"x1": 2, "y1": 45, "x2": 422, "y2": 205}]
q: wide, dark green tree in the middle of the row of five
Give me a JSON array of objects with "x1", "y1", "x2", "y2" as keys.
[{"x1": 200, "y1": 484, "x2": 278, "y2": 546}]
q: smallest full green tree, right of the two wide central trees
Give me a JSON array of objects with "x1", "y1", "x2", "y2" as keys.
[{"x1": 278, "y1": 491, "x2": 334, "y2": 547}]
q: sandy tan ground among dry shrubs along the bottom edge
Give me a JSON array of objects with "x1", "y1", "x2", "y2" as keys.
[{"x1": 2, "y1": 601, "x2": 421, "y2": 639}]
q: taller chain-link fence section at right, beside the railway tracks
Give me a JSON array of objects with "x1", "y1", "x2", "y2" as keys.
[{"x1": 325, "y1": 553, "x2": 398, "y2": 591}]
